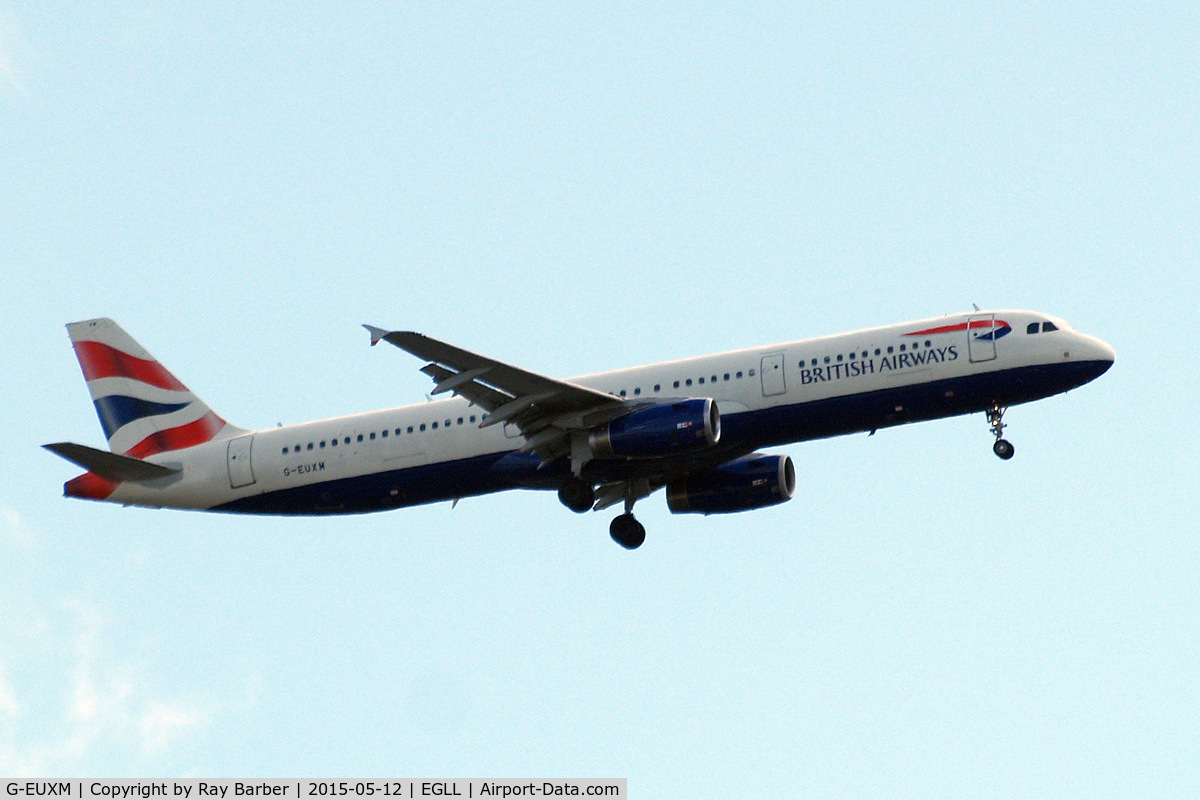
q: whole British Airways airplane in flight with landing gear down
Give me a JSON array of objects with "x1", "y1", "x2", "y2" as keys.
[{"x1": 44, "y1": 308, "x2": 1116, "y2": 549}]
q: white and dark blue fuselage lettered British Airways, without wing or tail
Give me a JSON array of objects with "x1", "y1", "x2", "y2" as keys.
[{"x1": 91, "y1": 311, "x2": 1112, "y2": 513}]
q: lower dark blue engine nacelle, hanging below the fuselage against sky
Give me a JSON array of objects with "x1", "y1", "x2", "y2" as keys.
[{"x1": 667, "y1": 453, "x2": 796, "y2": 515}]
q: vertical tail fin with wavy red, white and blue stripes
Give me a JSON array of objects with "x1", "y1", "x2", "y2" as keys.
[{"x1": 67, "y1": 319, "x2": 242, "y2": 458}]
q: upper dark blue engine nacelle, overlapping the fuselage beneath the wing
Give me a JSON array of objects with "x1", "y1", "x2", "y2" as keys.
[{"x1": 588, "y1": 398, "x2": 721, "y2": 458}]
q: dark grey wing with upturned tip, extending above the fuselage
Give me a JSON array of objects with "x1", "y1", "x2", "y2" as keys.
[{"x1": 364, "y1": 325, "x2": 641, "y2": 462}]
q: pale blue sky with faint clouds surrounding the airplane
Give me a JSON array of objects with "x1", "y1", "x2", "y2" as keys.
[{"x1": 0, "y1": 1, "x2": 1200, "y2": 798}]
